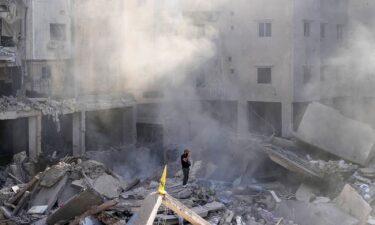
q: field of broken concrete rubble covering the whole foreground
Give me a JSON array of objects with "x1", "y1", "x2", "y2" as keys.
[{"x1": 0, "y1": 130, "x2": 375, "y2": 225}]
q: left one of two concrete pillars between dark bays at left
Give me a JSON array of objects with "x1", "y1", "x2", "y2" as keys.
[{"x1": 28, "y1": 115, "x2": 42, "y2": 160}]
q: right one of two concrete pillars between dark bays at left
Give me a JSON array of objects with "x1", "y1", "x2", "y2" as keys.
[{"x1": 73, "y1": 112, "x2": 86, "y2": 156}]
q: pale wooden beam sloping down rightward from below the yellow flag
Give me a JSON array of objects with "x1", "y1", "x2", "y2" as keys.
[{"x1": 163, "y1": 193, "x2": 210, "y2": 225}]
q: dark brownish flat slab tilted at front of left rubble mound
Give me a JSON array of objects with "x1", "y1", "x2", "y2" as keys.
[{"x1": 47, "y1": 189, "x2": 103, "y2": 225}]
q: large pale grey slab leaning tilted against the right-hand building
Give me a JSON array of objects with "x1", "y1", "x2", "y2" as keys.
[{"x1": 294, "y1": 102, "x2": 375, "y2": 165}]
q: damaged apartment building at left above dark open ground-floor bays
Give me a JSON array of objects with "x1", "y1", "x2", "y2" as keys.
[{"x1": 0, "y1": 0, "x2": 136, "y2": 160}]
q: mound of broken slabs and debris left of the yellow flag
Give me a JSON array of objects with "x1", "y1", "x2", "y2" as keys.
[{"x1": 0, "y1": 158, "x2": 127, "y2": 224}]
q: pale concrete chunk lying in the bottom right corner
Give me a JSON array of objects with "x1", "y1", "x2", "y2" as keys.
[{"x1": 336, "y1": 184, "x2": 372, "y2": 225}]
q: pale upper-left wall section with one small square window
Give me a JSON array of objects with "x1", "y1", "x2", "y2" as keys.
[{"x1": 26, "y1": 0, "x2": 71, "y2": 60}]
